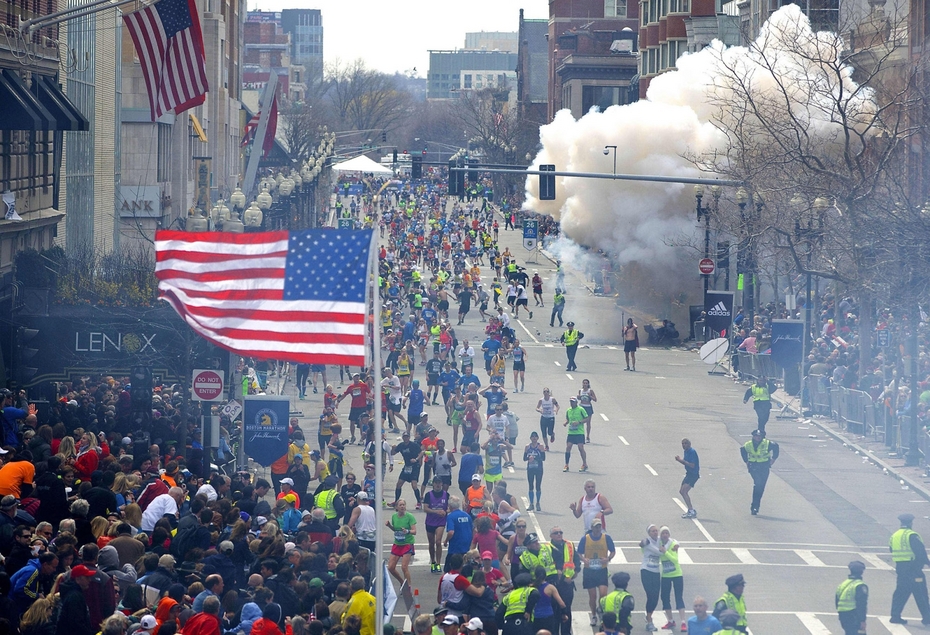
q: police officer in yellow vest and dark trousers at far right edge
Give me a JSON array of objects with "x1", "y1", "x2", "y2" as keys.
[{"x1": 888, "y1": 514, "x2": 930, "y2": 625}]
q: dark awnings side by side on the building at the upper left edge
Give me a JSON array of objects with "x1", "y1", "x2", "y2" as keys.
[{"x1": 0, "y1": 68, "x2": 90, "y2": 131}]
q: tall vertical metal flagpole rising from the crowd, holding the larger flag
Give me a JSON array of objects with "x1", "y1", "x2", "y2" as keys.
[{"x1": 368, "y1": 229, "x2": 387, "y2": 635}]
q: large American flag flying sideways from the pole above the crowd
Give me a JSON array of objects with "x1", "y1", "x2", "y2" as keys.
[{"x1": 155, "y1": 229, "x2": 372, "y2": 366}]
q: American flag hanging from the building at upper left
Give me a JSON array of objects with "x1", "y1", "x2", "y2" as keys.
[{"x1": 123, "y1": 0, "x2": 208, "y2": 121}]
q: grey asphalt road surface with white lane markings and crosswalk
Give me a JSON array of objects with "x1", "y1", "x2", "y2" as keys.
[{"x1": 274, "y1": 207, "x2": 930, "y2": 635}]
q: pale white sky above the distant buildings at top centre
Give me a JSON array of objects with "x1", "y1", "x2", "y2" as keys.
[{"x1": 248, "y1": 0, "x2": 549, "y2": 77}]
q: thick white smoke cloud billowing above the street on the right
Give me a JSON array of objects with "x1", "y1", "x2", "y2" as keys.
[{"x1": 524, "y1": 4, "x2": 872, "y2": 276}]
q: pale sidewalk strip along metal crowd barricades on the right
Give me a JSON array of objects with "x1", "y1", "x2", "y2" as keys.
[{"x1": 772, "y1": 388, "x2": 930, "y2": 501}]
